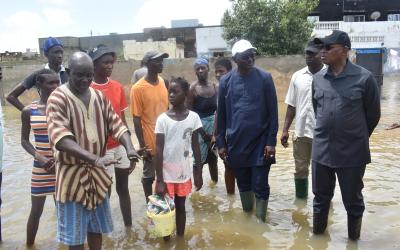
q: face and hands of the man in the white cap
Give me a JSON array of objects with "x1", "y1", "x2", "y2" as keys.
[{"x1": 218, "y1": 49, "x2": 275, "y2": 161}]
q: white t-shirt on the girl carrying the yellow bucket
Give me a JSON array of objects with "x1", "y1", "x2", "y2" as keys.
[{"x1": 154, "y1": 111, "x2": 202, "y2": 183}]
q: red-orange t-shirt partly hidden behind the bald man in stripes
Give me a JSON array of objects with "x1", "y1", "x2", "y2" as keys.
[{"x1": 90, "y1": 79, "x2": 128, "y2": 149}]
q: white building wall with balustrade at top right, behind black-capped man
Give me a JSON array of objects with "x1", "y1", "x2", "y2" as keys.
[{"x1": 314, "y1": 21, "x2": 400, "y2": 48}]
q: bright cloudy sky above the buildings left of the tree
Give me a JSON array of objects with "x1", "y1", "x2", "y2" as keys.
[{"x1": 0, "y1": 0, "x2": 231, "y2": 52}]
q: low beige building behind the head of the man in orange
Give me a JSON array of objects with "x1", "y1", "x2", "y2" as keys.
[{"x1": 123, "y1": 38, "x2": 184, "y2": 60}]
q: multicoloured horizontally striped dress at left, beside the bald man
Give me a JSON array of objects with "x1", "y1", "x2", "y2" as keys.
[{"x1": 30, "y1": 102, "x2": 56, "y2": 196}]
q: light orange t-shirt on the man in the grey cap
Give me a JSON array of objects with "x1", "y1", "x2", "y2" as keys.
[{"x1": 131, "y1": 77, "x2": 168, "y2": 155}]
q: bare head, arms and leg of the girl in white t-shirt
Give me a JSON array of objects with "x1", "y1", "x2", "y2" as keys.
[{"x1": 155, "y1": 82, "x2": 203, "y2": 236}]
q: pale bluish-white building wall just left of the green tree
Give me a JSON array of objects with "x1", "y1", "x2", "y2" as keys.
[{"x1": 196, "y1": 26, "x2": 230, "y2": 58}]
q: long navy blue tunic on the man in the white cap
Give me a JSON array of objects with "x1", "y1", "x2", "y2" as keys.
[{"x1": 217, "y1": 67, "x2": 278, "y2": 168}]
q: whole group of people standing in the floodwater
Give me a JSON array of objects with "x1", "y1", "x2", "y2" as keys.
[{"x1": 0, "y1": 28, "x2": 398, "y2": 249}]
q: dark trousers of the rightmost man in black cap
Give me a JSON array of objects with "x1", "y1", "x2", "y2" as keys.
[{"x1": 312, "y1": 161, "x2": 365, "y2": 218}]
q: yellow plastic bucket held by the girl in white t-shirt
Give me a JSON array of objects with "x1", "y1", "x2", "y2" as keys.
[{"x1": 147, "y1": 209, "x2": 175, "y2": 238}]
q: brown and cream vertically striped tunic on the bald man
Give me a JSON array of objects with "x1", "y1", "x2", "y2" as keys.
[{"x1": 46, "y1": 83, "x2": 128, "y2": 210}]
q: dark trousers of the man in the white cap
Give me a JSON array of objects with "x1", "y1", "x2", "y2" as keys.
[{"x1": 232, "y1": 165, "x2": 271, "y2": 200}]
